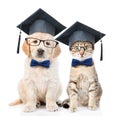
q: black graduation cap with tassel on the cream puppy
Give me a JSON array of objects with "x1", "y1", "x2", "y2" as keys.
[{"x1": 17, "y1": 9, "x2": 66, "y2": 53}]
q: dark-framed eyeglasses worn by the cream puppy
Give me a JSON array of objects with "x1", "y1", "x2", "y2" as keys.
[{"x1": 25, "y1": 37, "x2": 59, "y2": 48}]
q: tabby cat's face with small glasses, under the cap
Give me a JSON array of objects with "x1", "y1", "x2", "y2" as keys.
[{"x1": 70, "y1": 41, "x2": 94, "y2": 60}]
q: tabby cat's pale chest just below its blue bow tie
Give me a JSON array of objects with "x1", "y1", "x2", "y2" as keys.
[{"x1": 70, "y1": 66, "x2": 97, "y2": 91}]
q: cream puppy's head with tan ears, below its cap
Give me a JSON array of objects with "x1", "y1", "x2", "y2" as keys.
[{"x1": 22, "y1": 32, "x2": 61, "y2": 61}]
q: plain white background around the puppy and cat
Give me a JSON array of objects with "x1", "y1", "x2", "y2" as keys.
[{"x1": 0, "y1": 0, "x2": 120, "y2": 116}]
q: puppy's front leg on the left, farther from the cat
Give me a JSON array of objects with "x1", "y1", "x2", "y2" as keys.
[{"x1": 18, "y1": 79, "x2": 37, "y2": 112}]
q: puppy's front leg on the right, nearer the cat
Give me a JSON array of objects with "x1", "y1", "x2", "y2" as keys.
[{"x1": 46, "y1": 86, "x2": 58, "y2": 112}]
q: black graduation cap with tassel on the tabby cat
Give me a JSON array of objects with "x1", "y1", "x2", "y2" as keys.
[{"x1": 56, "y1": 22, "x2": 105, "y2": 60}]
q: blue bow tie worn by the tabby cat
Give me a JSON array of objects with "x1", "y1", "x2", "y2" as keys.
[{"x1": 72, "y1": 58, "x2": 93, "y2": 67}]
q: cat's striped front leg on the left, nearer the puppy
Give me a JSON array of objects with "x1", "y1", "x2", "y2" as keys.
[{"x1": 67, "y1": 82, "x2": 78, "y2": 112}]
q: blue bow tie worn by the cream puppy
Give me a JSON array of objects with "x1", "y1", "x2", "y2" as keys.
[{"x1": 30, "y1": 59, "x2": 50, "y2": 68}]
